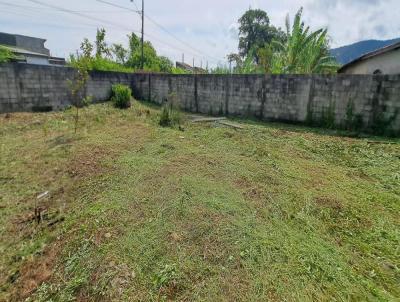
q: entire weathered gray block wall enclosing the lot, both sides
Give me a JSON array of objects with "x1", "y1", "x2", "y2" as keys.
[{"x1": 0, "y1": 64, "x2": 400, "y2": 134}]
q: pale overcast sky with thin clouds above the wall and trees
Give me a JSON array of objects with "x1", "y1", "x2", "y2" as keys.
[{"x1": 0, "y1": 0, "x2": 400, "y2": 66}]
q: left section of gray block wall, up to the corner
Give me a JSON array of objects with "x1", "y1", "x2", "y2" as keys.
[{"x1": 0, "y1": 64, "x2": 135, "y2": 113}]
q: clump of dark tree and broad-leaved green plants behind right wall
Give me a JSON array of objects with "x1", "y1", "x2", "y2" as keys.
[{"x1": 228, "y1": 8, "x2": 339, "y2": 74}]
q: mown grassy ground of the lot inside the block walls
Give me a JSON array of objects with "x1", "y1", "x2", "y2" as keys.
[{"x1": 0, "y1": 103, "x2": 400, "y2": 301}]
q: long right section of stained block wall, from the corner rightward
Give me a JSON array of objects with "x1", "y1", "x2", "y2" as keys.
[{"x1": 133, "y1": 74, "x2": 400, "y2": 133}]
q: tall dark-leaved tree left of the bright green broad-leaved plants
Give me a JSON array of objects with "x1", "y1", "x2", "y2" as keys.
[{"x1": 239, "y1": 9, "x2": 285, "y2": 61}]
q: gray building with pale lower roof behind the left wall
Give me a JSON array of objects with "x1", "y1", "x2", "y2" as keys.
[{"x1": 0, "y1": 33, "x2": 65, "y2": 65}]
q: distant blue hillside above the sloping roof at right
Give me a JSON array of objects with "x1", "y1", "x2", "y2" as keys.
[{"x1": 331, "y1": 38, "x2": 400, "y2": 64}]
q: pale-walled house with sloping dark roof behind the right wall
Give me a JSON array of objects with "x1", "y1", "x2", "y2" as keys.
[{"x1": 338, "y1": 42, "x2": 400, "y2": 74}]
